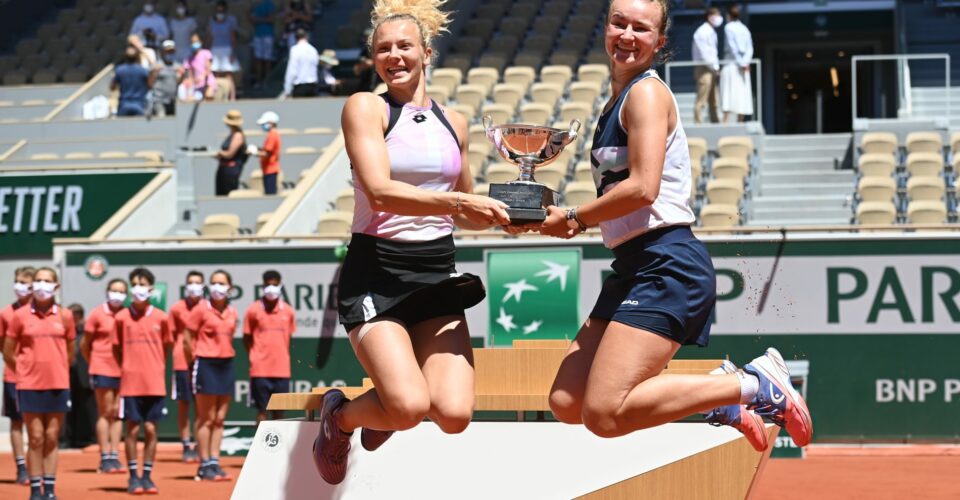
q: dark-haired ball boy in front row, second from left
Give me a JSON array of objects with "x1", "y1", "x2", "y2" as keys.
[{"x1": 111, "y1": 267, "x2": 173, "y2": 495}]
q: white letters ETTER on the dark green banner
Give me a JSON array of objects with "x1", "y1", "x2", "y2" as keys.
[{"x1": 0, "y1": 186, "x2": 83, "y2": 233}]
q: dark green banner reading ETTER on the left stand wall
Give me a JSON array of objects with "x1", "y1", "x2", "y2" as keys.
[{"x1": 0, "y1": 173, "x2": 156, "y2": 259}]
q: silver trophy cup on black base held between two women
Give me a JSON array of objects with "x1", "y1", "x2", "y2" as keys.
[{"x1": 483, "y1": 116, "x2": 580, "y2": 225}]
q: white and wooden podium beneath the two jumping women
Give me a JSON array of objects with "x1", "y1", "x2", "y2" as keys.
[{"x1": 233, "y1": 341, "x2": 778, "y2": 500}]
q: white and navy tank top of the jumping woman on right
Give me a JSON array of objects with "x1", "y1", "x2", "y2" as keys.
[{"x1": 590, "y1": 69, "x2": 696, "y2": 248}]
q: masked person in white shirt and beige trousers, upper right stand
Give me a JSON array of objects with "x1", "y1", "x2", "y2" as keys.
[{"x1": 693, "y1": 7, "x2": 723, "y2": 123}]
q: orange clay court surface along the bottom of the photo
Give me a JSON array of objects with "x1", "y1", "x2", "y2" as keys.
[{"x1": 0, "y1": 445, "x2": 960, "y2": 500}]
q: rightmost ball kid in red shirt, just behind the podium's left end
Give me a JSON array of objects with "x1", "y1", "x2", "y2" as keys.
[{"x1": 243, "y1": 269, "x2": 297, "y2": 424}]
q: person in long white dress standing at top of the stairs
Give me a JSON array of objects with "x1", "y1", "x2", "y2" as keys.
[{"x1": 720, "y1": 5, "x2": 753, "y2": 122}]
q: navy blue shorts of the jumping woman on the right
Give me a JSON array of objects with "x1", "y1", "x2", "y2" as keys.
[{"x1": 590, "y1": 226, "x2": 717, "y2": 346}]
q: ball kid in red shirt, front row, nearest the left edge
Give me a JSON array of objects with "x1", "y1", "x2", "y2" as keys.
[{"x1": 3, "y1": 267, "x2": 76, "y2": 500}]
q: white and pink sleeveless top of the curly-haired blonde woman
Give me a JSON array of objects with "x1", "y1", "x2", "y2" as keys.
[{"x1": 351, "y1": 93, "x2": 461, "y2": 241}]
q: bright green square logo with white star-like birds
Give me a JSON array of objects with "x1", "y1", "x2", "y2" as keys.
[{"x1": 487, "y1": 249, "x2": 580, "y2": 345}]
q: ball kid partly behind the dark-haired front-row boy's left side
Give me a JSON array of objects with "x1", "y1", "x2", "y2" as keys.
[{"x1": 80, "y1": 279, "x2": 127, "y2": 474}]
